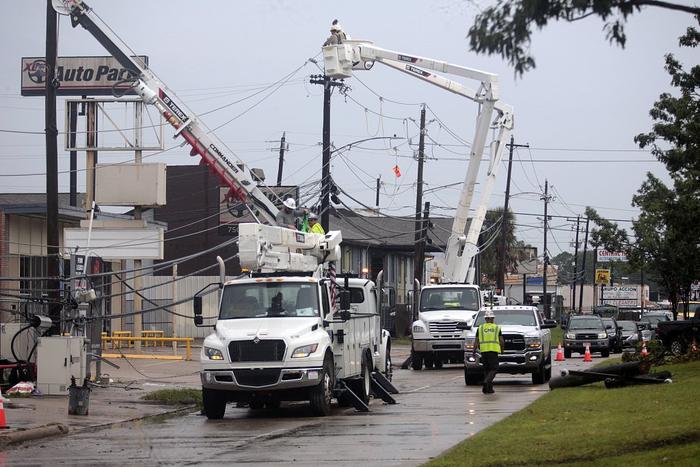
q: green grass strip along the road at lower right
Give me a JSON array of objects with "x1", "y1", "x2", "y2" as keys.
[{"x1": 426, "y1": 361, "x2": 700, "y2": 467}]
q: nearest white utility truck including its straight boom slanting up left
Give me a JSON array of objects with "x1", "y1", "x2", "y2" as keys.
[{"x1": 54, "y1": 0, "x2": 398, "y2": 419}]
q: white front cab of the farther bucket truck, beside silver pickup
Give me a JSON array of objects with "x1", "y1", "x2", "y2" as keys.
[{"x1": 411, "y1": 284, "x2": 482, "y2": 370}]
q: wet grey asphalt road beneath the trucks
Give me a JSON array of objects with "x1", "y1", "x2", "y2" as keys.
[{"x1": 5, "y1": 358, "x2": 590, "y2": 467}]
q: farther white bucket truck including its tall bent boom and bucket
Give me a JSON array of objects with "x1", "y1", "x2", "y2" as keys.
[{"x1": 323, "y1": 35, "x2": 513, "y2": 370}]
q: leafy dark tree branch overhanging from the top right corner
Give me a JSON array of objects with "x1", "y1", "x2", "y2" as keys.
[{"x1": 468, "y1": 0, "x2": 700, "y2": 75}]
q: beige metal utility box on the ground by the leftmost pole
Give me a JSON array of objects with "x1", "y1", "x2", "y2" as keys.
[{"x1": 36, "y1": 336, "x2": 86, "y2": 396}]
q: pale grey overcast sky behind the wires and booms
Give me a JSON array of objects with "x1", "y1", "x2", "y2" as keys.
[{"x1": 0, "y1": 0, "x2": 697, "y2": 256}]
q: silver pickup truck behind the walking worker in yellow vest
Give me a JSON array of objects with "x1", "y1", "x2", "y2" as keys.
[{"x1": 464, "y1": 306, "x2": 556, "y2": 385}]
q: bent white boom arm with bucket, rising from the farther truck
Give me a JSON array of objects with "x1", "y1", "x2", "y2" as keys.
[{"x1": 323, "y1": 40, "x2": 513, "y2": 283}]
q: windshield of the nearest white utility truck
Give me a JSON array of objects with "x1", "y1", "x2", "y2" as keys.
[{"x1": 219, "y1": 282, "x2": 319, "y2": 319}]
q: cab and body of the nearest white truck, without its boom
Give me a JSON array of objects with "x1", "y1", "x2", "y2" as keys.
[{"x1": 195, "y1": 276, "x2": 395, "y2": 419}]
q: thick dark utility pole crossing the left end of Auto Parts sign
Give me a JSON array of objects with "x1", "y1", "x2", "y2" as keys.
[{"x1": 44, "y1": 0, "x2": 61, "y2": 335}]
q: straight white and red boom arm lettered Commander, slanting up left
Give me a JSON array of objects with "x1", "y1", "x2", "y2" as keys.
[{"x1": 54, "y1": 0, "x2": 278, "y2": 225}]
